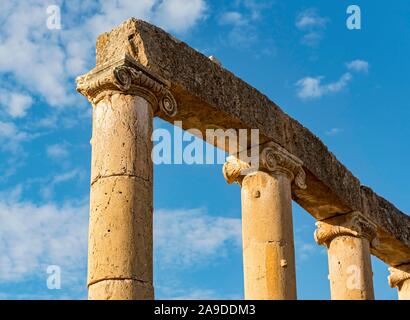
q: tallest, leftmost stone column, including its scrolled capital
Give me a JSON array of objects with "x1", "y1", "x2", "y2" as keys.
[{"x1": 77, "y1": 57, "x2": 176, "y2": 300}]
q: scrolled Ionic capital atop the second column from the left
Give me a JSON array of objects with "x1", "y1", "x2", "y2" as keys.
[{"x1": 223, "y1": 142, "x2": 306, "y2": 189}]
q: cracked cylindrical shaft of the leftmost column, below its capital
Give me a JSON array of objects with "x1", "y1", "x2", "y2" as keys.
[{"x1": 88, "y1": 93, "x2": 154, "y2": 300}]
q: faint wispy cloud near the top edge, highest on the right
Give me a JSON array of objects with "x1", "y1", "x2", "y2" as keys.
[{"x1": 295, "y1": 8, "x2": 329, "y2": 46}]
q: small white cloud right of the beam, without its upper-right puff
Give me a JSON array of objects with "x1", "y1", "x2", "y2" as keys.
[{"x1": 296, "y1": 72, "x2": 352, "y2": 99}]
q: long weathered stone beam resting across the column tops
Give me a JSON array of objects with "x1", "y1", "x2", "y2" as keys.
[{"x1": 91, "y1": 19, "x2": 410, "y2": 266}]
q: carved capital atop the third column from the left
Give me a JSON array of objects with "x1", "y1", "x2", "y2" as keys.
[{"x1": 314, "y1": 211, "x2": 376, "y2": 247}]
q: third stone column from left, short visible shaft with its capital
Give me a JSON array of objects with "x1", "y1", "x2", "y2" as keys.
[{"x1": 315, "y1": 212, "x2": 376, "y2": 300}]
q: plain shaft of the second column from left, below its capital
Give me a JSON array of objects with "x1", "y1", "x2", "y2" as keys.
[{"x1": 242, "y1": 171, "x2": 296, "y2": 300}]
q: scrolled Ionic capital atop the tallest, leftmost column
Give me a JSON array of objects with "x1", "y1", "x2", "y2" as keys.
[{"x1": 76, "y1": 55, "x2": 177, "y2": 117}]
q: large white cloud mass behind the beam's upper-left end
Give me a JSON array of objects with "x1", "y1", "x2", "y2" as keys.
[{"x1": 0, "y1": 0, "x2": 206, "y2": 110}]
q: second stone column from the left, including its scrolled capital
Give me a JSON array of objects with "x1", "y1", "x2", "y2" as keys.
[{"x1": 223, "y1": 143, "x2": 306, "y2": 300}]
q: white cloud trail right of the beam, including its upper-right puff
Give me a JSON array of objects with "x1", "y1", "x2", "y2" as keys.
[{"x1": 295, "y1": 60, "x2": 369, "y2": 99}]
